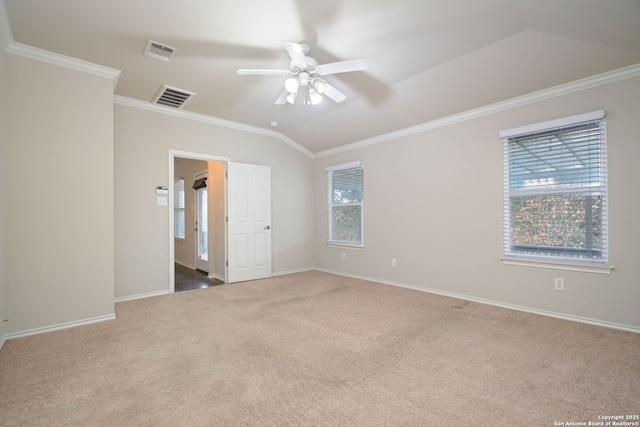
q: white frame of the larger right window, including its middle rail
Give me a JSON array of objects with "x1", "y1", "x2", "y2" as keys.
[{"x1": 499, "y1": 110, "x2": 613, "y2": 274}]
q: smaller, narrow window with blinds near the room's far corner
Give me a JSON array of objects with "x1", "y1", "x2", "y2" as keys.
[{"x1": 327, "y1": 162, "x2": 363, "y2": 246}]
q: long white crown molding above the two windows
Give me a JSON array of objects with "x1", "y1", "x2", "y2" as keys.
[{"x1": 314, "y1": 64, "x2": 640, "y2": 158}]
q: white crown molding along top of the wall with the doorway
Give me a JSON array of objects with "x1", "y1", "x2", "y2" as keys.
[{"x1": 114, "y1": 95, "x2": 314, "y2": 159}]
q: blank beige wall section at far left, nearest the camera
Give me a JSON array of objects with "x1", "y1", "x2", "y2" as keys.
[{"x1": 2, "y1": 54, "x2": 114, "y2": 333}]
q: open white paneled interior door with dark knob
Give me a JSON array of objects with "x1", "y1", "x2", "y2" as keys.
[{"x1": 227, "y1": 162, "x2": 271, "y2": 283}]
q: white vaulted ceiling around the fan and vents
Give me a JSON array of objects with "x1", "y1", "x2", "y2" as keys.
[{"x1": 4, "y1": 0, "x2": 640, "y2": 153}]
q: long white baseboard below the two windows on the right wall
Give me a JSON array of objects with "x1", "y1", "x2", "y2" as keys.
[{"x1": 315, "y1": 268, "x2": 640, "y2": 334}]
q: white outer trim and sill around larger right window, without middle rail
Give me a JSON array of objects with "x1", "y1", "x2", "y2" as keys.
[{"x1": 499, "y1": 110, "x2": 614, "y2": 274}]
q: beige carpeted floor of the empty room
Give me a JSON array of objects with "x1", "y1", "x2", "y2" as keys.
[{"x1": 0, "y1": 271, "x2": 640, "y2": 426}]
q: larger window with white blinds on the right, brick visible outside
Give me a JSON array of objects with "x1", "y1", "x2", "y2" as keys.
[{"x1": 500, "y1": 111, "x2": 608, "y2": 264}]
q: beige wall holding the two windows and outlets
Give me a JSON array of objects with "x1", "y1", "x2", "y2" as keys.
[{"x1": 314, "y1": 78, "x2": 640, "y2": 328}]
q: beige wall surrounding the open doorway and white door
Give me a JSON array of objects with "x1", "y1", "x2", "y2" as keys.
[{"x1": 115, "y1": 104, "x2": 313, "y2": 298}]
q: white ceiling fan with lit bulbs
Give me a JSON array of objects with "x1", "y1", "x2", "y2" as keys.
[{"x1": 237, "y1": 42, "x2": 369, "y2": 105}]
